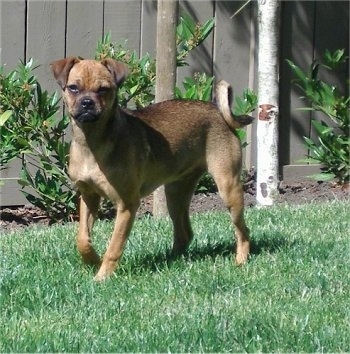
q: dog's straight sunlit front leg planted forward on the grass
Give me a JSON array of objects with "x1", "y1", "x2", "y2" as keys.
[{"x1": 95, "y1": 201, "x2": 140, "y2": 281}]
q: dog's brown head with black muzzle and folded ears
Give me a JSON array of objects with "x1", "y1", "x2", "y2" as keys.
[{"x1": 51, "y1": 57, "x2": 128, "y2": 123}]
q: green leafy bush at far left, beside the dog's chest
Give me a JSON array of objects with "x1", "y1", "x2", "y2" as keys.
[{"x1": 0, "y1": 59, "x2": 77, "y2": 219}]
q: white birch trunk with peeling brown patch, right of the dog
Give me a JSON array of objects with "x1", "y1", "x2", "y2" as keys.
[{"x1": 256, "y1": 0, "x2": 280, "y2": 205}]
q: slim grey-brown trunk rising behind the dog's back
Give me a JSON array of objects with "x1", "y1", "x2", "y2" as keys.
[{"x1": 153, "y1": 0, "x2": 178, "y2": 217}]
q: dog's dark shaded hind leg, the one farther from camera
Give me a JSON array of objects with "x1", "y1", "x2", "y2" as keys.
[{"x1": 165, "y1": 171, "x2": 202, "y2": 255}]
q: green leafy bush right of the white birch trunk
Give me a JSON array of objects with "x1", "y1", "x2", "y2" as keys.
[{"x1": 287, "y1": 49, "x2": 350, "y2": 184}]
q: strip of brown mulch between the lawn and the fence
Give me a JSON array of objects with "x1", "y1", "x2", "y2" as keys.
[{"x1": 0, "y1": 179, "x2": 349, "y2": 231}]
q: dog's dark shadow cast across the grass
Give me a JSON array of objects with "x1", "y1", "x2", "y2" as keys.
[{"x1": 122, "y1": 233, "x2": 294, "y2": 273}]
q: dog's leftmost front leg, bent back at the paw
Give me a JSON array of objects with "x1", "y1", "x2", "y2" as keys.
[{"x1": 77, "y1": 193, "x2": 100, "y2": 265}]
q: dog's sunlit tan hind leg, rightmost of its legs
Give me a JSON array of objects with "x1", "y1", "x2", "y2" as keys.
[{"x1": 212, "y1": 166, "x2": 250, "y2": 265}]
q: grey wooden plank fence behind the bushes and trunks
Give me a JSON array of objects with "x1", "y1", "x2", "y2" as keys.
[{"x1": 0, "y1": 0, "x2": 349, "y2": 205}]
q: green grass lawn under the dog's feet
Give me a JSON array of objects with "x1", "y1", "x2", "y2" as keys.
[{"x1": 0, "y1": 202, "x2": 350, "y2": 352}]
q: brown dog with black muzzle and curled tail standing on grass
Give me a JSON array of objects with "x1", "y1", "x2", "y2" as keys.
[{"x1": 51, "y1": 57, "x2": 253, "y2": 281}]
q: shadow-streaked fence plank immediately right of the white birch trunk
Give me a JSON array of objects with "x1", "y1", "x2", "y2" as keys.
[{"x1": 279, "y1": 1, "x2": 315, "y2": 176}]
